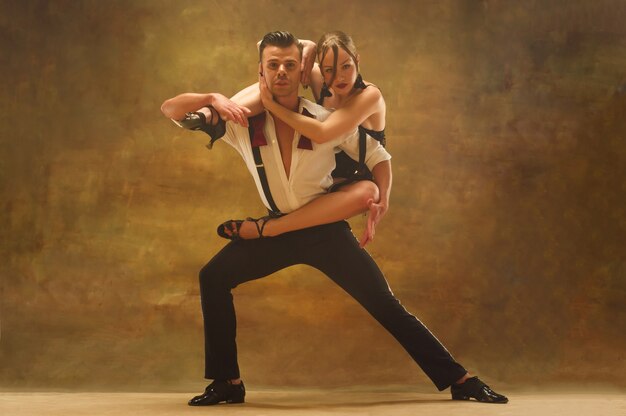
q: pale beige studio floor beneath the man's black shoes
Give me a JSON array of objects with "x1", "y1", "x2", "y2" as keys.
[{"x1": 0, "y1": 390, "x2": 626, "y2": 416}]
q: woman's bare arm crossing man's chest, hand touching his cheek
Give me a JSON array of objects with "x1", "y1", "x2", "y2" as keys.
[{"x1": 259, "y1": 74, "x2": 384, "y2": 143}]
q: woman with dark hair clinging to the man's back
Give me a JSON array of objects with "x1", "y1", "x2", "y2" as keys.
[{"x1": 216, "y1": 31, "x2": 391, "y2": 246}]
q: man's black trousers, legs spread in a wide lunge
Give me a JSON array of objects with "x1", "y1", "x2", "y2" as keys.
[{"x1": 200, "y1": 221, "x2": 466, "y2": 390}]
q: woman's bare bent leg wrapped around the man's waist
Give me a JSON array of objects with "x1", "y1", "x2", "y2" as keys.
[{"x1": 239, "y1": 181, "x2": 379, "y2": 239}]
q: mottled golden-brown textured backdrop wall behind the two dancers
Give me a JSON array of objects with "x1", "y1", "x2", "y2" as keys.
[{"x1": 0, "y1": 0, "x2": 626, "y2": 391}]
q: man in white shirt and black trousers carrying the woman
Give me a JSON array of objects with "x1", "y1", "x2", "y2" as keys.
[{"x1": 162, "y1": 32, "x2": 508, "y2": 406}]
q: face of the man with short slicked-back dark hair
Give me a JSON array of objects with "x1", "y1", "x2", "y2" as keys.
[{"x1": 262, "y1": 45, "x2": 301, "y2": 97}]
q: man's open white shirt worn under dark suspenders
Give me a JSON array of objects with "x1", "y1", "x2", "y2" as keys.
[{"x1": 214, "y1": 97, "x2": 391, "y2": 214}]
